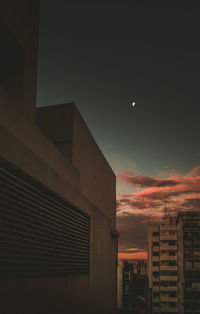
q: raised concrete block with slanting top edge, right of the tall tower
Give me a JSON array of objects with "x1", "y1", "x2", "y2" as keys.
[{"x1": 37, "y1": 103, "x2": 116, "y2": 228}]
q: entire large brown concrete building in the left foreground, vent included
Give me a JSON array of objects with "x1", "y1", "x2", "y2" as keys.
[{"x1": 0, "y1": 0, "x2": 118, "y2": 314}]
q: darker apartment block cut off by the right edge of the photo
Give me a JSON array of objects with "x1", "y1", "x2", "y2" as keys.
[{"x1": 177, "y1": 212, "x2": 200, "y2": 314}]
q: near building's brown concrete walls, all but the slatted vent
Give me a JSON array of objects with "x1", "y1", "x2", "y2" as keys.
[{"x1": 0, "y1": 0, "x2": 117, "y2": 314}]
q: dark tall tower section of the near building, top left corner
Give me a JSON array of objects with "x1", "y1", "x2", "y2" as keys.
[{"x1": 0, "y1": 0, "x2": 39, "y2": 121}]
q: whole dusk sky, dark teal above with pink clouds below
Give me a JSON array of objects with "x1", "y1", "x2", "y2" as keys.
[{"x1": 38, "y1": 0, "x2": 200, "y2": 259}]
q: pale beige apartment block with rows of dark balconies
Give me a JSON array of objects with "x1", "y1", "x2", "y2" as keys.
[{"x1": 148, "y1": 216, "x2": 178, "y2": 314}]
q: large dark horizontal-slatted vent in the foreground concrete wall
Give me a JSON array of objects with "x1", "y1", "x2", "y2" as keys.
[{"x1": 0, "y1": 158, "x2": 90, "y2": 278}]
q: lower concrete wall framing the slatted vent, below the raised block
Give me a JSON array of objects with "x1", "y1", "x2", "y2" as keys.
[{"x1": 0, "y1": 88, "x2": 117, "y2": 314}]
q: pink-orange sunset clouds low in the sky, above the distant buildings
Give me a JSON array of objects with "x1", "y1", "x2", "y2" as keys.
[{"x1": 117, "y1": 166, "x2": 200, "y2": 259}]
